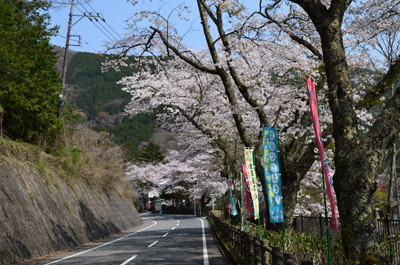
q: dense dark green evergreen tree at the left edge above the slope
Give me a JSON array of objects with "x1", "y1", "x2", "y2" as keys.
[{"x1": 0, "y1": 0, "x2": 62, "y2": 143}]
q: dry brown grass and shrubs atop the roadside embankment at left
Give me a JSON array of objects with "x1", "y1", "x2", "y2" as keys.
[{"x1": 0, "y1": 125, "x2": 132, "y2": 198}]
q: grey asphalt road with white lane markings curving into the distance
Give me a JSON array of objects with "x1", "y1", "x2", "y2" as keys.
[{"x1": 25, "y1": 214, "x2": 230, "y2": 265}]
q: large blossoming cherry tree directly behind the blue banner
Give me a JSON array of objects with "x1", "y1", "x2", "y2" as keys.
[{"x1": 110, "y1": 1, "x2": 329, "y2": 229}]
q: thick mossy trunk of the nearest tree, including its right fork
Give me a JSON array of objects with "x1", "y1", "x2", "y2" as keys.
[{"x1": 305, "y1": 1, "x2": 400, "y2": 264}]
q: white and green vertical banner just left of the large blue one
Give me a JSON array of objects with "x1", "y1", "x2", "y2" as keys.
[{"x1": 243, "y1": 147, "x2": 260, "y2": 220}]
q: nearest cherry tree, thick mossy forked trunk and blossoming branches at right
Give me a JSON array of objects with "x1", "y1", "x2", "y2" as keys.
[{"x1": 259, "y1": 0, "x2": 400, "y2": 263}]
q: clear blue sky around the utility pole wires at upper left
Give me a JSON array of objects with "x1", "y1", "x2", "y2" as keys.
[{"x1": 49, "y1": 0, "x2": 205, "y2": 53}]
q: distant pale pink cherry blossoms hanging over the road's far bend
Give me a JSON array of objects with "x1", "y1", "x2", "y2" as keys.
[{"x1": 126, "y1": 131, "x2": 227, "y2": 199}]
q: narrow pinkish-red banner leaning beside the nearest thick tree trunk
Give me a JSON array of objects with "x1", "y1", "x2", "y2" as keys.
[{"x1": 307, "y1": 76, "x2": 338, "y2": 230}]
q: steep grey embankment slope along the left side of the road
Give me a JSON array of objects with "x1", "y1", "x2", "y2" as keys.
[{"x1": 0, "y1": 138, "x2": 142, "y2": 264}]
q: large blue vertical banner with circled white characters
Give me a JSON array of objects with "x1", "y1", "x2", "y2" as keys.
[{"x1": 263, "y1": 127, "x2": 284, "y2": 223}]
